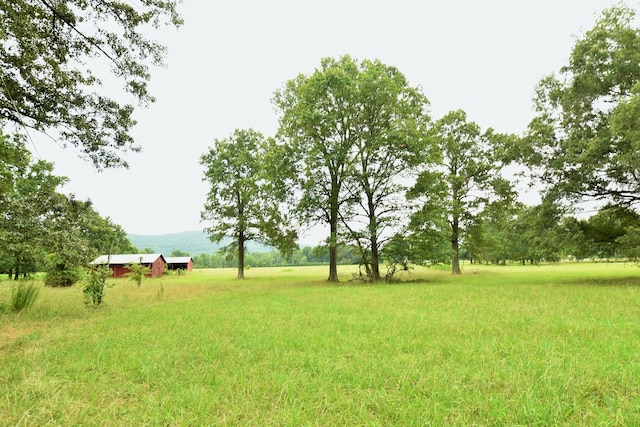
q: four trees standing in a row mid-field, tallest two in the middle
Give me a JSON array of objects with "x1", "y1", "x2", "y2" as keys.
[{"x1": 201, "y1": 56, "x2": 514, "y2": 281}]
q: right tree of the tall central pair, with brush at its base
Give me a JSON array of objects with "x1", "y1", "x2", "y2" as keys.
[{"x1": 344, "y1": 60, "x2": 432, "y2": 281}]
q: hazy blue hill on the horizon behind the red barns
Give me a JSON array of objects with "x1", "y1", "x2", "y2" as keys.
[{"x1": 127, "y1": 231, "x2": 274, "y2": 256}]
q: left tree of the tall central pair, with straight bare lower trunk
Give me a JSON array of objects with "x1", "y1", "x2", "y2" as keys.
[{"x1": 274, "y1": 56, "x2": 359, "y2": 282}]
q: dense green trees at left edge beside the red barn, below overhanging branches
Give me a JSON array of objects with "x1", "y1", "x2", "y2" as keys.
[{"x1": 0, "y1": 133, "x2": 135, "y2": 286}]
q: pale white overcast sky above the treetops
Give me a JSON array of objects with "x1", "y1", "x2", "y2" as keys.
[{"x1": 28, "y1": 0, "x2": 624, "y2": 241}]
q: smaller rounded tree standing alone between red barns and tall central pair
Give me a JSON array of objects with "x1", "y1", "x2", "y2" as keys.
[{"x1": 200, "y1": 129, "x2": 297, "y2": 279}]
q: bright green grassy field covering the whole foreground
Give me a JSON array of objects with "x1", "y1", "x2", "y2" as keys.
[{"x1": 0, "y1": 263, "x2": 640, "y2": 426}]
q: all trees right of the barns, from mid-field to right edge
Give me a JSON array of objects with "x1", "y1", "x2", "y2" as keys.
[{"x1": 200, "y1": 5, "x2": 640, "y2": 281}]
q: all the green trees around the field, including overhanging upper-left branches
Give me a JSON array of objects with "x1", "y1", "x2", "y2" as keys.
[{"x1": 0, "y1": 4, "x2": 640, "y2": 285}]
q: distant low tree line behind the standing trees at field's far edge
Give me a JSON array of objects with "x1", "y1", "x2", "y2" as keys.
[{"x1": 189, "y1": 201, "x2": 640, "y2": 270}]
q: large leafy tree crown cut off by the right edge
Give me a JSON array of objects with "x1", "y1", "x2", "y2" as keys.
[{"x1": 519, "y1": 5, "x2": 640, "y2": 204}]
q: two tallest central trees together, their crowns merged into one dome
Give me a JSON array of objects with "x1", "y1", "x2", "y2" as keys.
[{"x1": 274, "y1": 56, "x2": 428, "y2": 282}]
